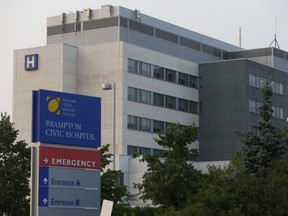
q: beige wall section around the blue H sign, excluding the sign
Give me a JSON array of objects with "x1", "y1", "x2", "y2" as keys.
[{"x1": 13, "y1": 44, "x2": 73, "y2": 144}]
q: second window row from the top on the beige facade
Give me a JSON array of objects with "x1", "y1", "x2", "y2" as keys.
[{"x1": 128, "y1": 87, "x2": 199, "y2": 114}]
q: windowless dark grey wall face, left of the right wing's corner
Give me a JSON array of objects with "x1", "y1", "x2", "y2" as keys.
[{"x1": 199, "y1": 61, "x2": 248, "y2": 161}]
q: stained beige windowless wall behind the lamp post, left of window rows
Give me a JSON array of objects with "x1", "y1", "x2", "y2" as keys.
[{"x1": 77, "y1": 42, "x2": 123, "y2": 154}]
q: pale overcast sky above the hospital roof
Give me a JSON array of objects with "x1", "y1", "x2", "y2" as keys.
[{"x1": 0, "y1": 0, "x2": 288, "y2": 114}]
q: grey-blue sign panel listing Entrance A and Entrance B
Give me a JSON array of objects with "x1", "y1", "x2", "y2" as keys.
[{"x1": 38, "y1": 166, "x2": 100, "y2": 209}]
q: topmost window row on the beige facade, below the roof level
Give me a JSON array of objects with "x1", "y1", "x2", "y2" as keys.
[{"x1": 128, "y1": 59, "x2": 198, "y2": 88}]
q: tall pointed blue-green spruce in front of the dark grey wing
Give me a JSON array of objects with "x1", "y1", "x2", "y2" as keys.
[{"x1": 239, "y1": 79, "x2": 287, "y2": 174}]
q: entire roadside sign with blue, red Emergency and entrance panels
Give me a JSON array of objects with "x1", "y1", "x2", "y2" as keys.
[{"x1": 31, "y1": 90, "x2": 101, "y2": 216}]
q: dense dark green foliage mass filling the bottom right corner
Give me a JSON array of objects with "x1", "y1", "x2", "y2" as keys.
[{"x1": 188, "y1": 160, "x2": 288, "y2": 216}]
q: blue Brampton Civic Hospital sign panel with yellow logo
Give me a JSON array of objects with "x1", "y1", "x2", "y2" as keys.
[{"x1": 32, "y1": 90, "x2": 101, "y2": 147}]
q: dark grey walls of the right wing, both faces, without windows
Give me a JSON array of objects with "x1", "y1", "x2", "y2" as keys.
[{"x1": 199, "y1": 59, "x2": 288, "y2": 161}]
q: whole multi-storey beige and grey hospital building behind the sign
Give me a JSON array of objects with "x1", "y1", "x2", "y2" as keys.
[{"x1": 13, "y1": 5, "x2": 288, "y2": 204}]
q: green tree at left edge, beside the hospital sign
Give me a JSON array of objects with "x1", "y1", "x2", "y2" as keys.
[{"x1": 0, "y1": 113, "x2": 31, "y2": 215}]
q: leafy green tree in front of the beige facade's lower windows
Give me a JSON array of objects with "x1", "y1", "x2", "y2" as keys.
[{"x1": 135, "y1": 124, "x2": 201, "y2": 209}]
